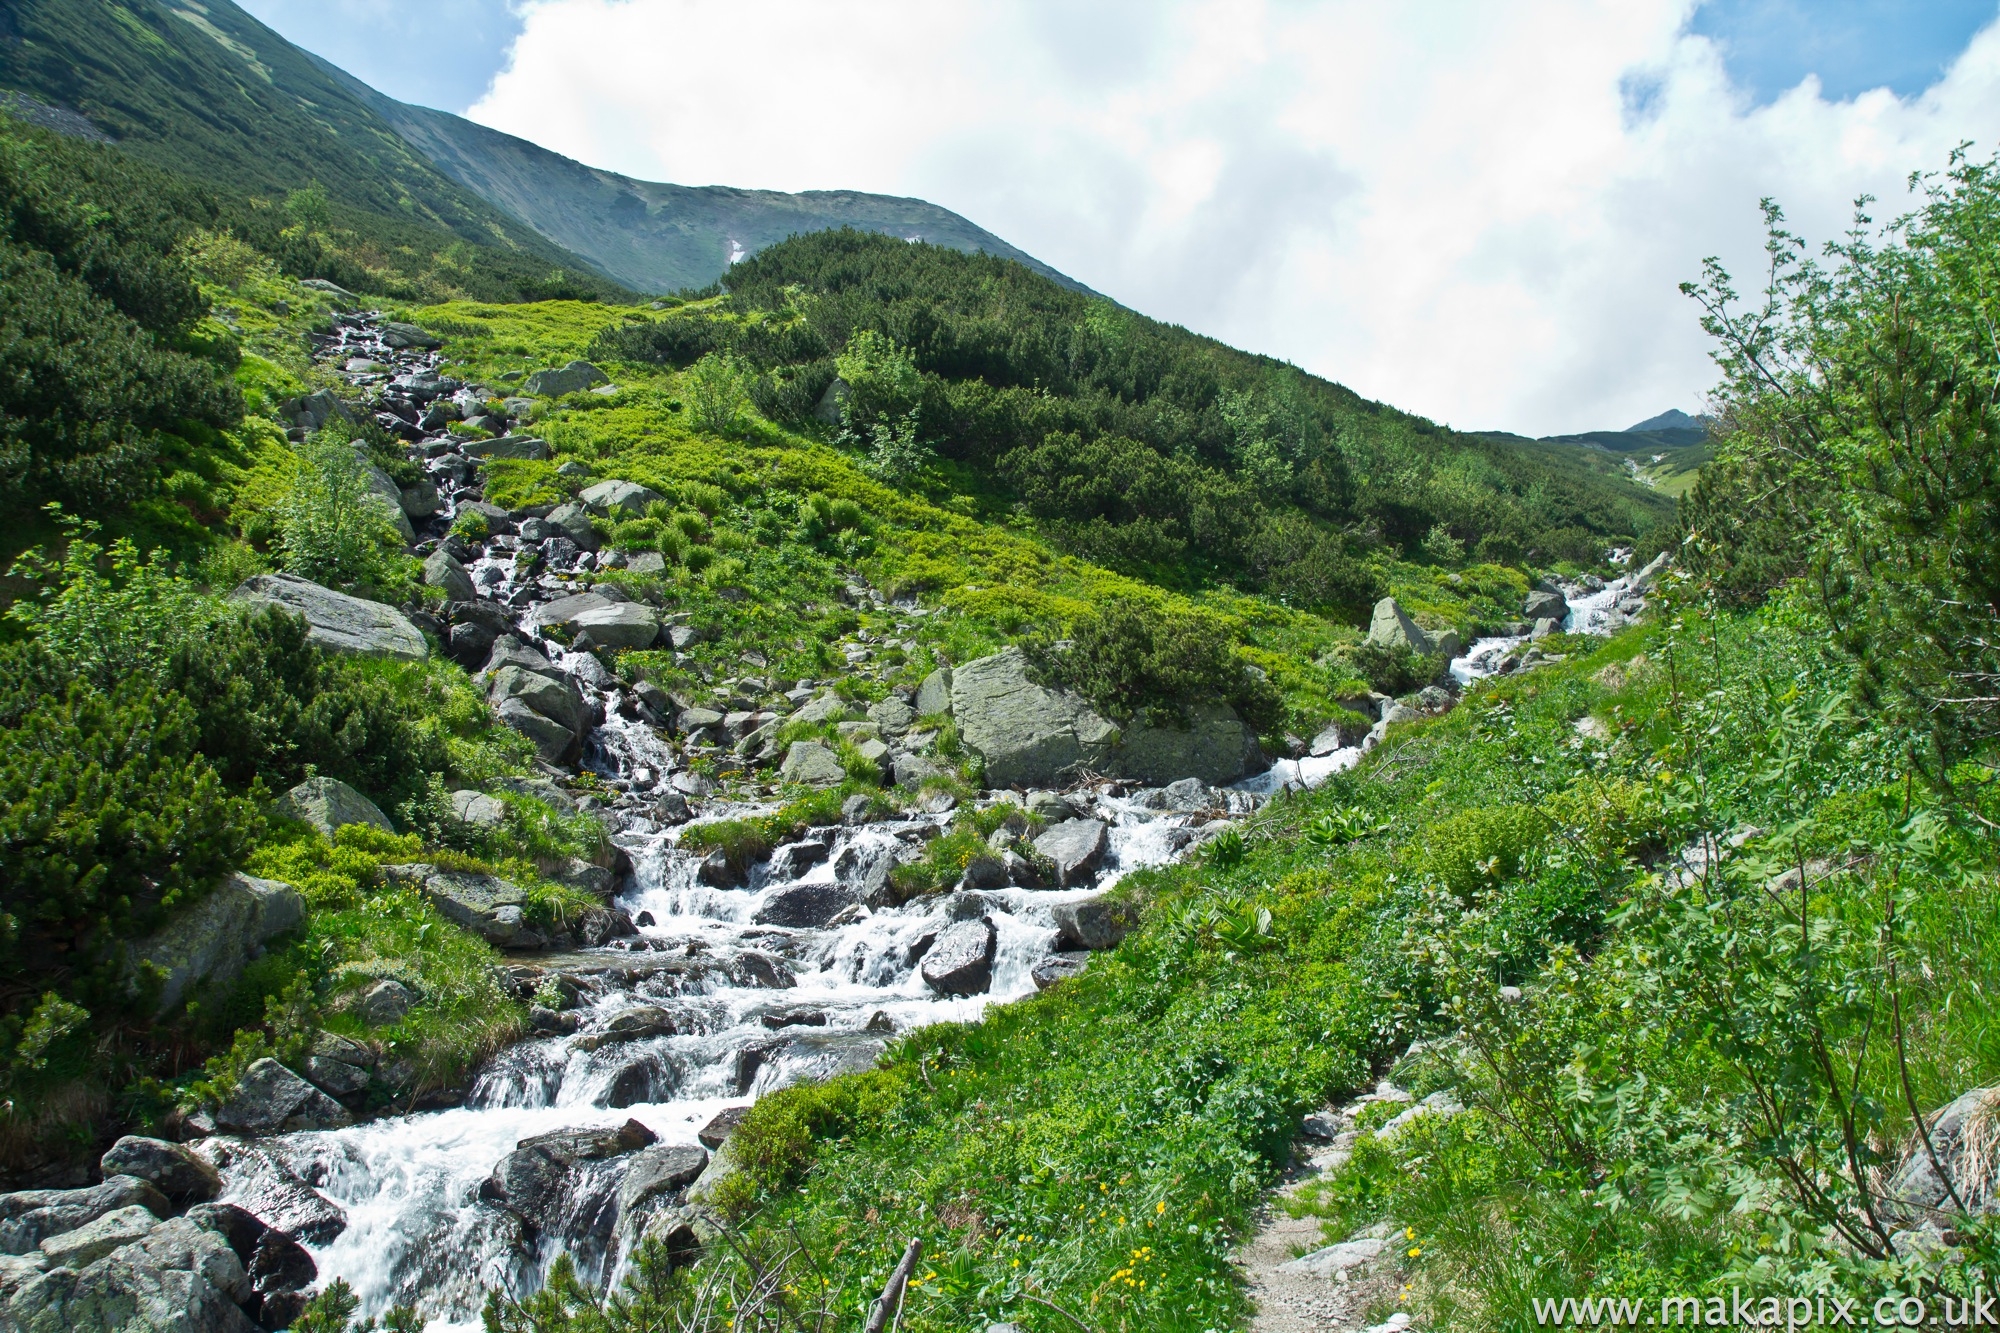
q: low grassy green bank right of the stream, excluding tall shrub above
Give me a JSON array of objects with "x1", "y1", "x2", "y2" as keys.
[{"x1": 498, "y1": 598, "x2": 2000, "y2": 1333}]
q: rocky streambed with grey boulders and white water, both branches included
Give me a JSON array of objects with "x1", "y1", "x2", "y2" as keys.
[{"x1": 0, "y1": 304, "x2": 1656, "y2": 1329}]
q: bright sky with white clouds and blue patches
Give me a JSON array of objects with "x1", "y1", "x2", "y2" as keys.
[{"x1": 242, "y1": 0, "x2": 2000, "y2": 434}]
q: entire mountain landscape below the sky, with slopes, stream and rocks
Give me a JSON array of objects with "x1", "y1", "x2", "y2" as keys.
[{"x1": 0, "y1": 0, "x2": 2000, "y2": 1333}]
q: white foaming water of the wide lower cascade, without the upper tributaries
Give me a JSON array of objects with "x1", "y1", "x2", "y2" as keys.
[{"x1": 224, "y1": 784, "x2": 1256, "y2": 1331}]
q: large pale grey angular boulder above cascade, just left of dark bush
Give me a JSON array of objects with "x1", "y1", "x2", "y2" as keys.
[{"x1": 944, "y1": 648, "x2": 1120, "y2": 787}]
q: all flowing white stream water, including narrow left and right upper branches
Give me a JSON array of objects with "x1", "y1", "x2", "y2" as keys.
[{"x1": 204, "y1": 306, "x2": 1656, "y2": 1333}]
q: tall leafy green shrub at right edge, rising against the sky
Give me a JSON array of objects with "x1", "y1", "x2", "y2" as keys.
[{"x1": 1682, "y1": 152, "x2": 2000, "y2": 773}]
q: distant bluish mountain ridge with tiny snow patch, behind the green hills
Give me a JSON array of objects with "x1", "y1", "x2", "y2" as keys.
[{"x1": 322, "y1": 53, "x2": 1082, "y2": 292}]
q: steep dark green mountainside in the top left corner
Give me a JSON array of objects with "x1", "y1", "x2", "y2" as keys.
[{"x1": 0, "y1": 0, "x2": 620, "y2": 296}]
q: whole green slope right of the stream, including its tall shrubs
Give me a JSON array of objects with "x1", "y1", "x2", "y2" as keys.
[{"x1": 490, "y1": 160, "x2": 2000, "y2": 1333}]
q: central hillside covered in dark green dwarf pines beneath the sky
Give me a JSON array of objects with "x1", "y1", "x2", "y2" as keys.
[{"x1": 594, "y1": 232, "x2": 1670, "y2": 628}]
